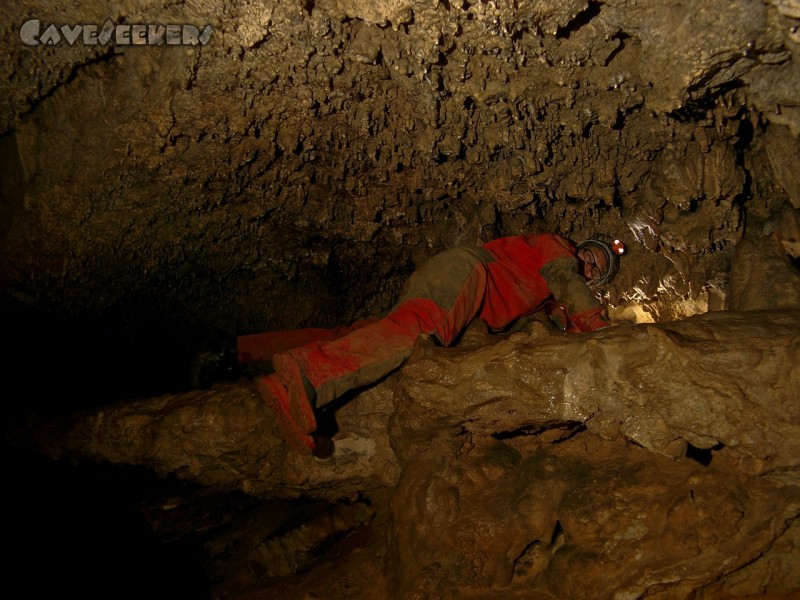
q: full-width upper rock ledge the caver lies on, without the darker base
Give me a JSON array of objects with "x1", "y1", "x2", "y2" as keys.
[{"x1": 25, "y1": 310, "x2": 800, "y2": 482}]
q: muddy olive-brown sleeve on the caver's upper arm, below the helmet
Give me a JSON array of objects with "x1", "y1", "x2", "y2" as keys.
[{"x1": 539, "y1": 257, "x2": 611, "y2": 333}]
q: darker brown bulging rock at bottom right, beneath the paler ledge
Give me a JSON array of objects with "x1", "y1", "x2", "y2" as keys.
[{"x1": 393, "y1": 434, "x2": 800, "y2": 599}]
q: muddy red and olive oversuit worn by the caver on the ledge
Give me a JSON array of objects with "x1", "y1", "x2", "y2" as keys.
[{"x1": 247, "y1": 234, "x2": 610, "y2": 451}]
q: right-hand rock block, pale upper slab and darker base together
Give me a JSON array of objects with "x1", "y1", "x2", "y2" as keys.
[{"x1": 382, "y1": 311, "x2": 800, "y2": 598}]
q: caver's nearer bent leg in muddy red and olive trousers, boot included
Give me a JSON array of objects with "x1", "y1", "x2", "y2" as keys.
[{"x1": 260, "y1": 248, "x2": 491, "y2": 448}]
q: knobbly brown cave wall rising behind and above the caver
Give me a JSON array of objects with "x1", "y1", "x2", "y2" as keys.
[{"x1": 0, "y1": 0, "x2": 800, "y2": 342}]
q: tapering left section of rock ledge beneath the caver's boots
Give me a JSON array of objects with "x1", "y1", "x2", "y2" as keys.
[{"x1": 20, "y1": 380, "x2": 398, "y2": 501}]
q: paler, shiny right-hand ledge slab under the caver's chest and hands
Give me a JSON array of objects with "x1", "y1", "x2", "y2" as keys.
[{"x1": 393, "y1": 310, "x2": 800, "y2": 471}]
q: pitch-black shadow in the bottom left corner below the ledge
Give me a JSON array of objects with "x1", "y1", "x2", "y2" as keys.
[{"x1": 2, "y1": 442, "x2": 211, "y2": 600}]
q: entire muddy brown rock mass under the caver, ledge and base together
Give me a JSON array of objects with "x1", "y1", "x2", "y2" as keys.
[{"x1": 15, "y1": 310, "x2": 800, "y2": 599}]
